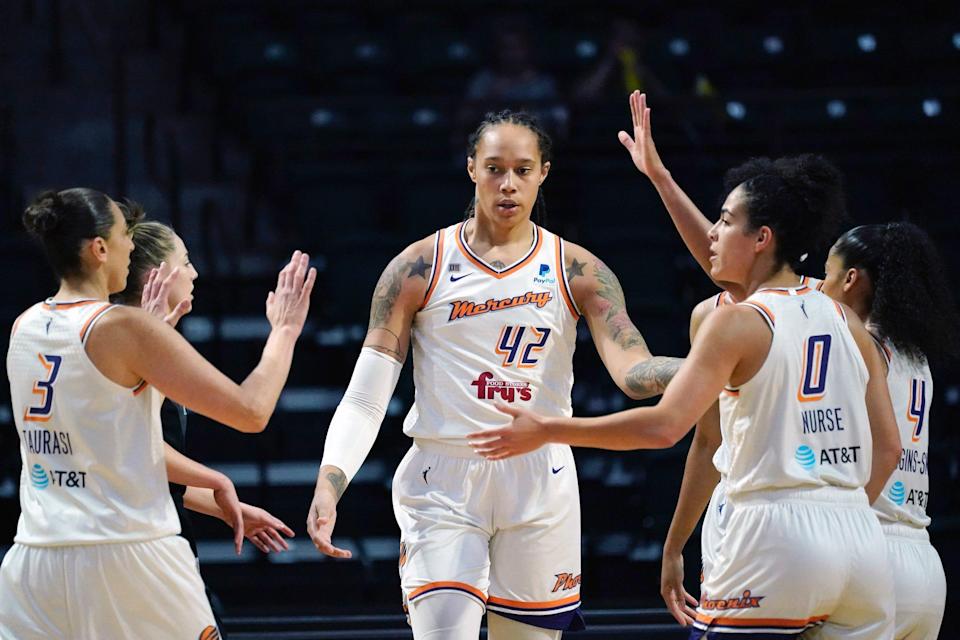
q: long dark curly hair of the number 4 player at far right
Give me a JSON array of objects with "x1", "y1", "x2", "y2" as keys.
[{"x1": 832, "y1": 222, "x2": 960, "y2": 361}]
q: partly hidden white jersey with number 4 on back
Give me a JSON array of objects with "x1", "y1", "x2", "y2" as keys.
[{"x1": 873, "y1": 343, "x2": 933, "y2": 528}]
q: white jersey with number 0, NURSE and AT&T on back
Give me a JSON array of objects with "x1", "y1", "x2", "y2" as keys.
[{"x1": 715, "y1": 285, "x2": 872, "y2": 494}]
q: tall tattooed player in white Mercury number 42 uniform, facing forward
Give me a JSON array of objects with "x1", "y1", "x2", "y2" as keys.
[{"x1": 307, "y1": 111, "x2": 678, "y2": 640}]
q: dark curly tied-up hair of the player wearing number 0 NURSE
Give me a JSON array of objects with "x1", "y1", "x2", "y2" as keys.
[{"x1": 723, "y1": 154, "x2": 846, "y2": 271}]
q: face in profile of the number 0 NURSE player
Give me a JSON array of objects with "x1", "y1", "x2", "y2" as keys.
[{"x1": 710, "y1": 186, "x2": 757, "y2": 283}]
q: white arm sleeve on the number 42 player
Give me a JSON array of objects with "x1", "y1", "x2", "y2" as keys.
[{"x1": 320, "y1": 347, "x2": 403, "y2": 482}]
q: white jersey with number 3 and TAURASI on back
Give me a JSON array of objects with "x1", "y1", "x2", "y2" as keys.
[{"x1": 7, "y1": 300, "x2": 180, "y2": 546}]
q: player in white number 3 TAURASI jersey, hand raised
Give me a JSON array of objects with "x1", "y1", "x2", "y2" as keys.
[{"x1": 0, "y1": 189, "x2": 315, "y2": 640}]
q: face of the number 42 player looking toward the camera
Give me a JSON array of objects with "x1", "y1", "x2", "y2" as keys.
[{"x1": 467, "y1": 124, "x2": 550, "y2": 227}]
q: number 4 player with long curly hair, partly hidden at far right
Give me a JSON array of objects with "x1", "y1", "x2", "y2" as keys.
[{"x1": 822, "y1": 222, "x2": 960, "y2": 640}]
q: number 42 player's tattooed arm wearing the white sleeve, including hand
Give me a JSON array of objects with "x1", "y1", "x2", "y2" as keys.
[{"x1": 307, "y1": 236, "x2": 433, "y2": 558}]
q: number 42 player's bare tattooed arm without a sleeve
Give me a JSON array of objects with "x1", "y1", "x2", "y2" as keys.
[{"x1": 564, "y1": 243, "x2": 683, "y2": 400}]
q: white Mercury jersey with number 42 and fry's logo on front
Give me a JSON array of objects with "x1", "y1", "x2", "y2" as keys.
[{"x1": 403, "y1": 222, "x2": 580, "y2": 445}]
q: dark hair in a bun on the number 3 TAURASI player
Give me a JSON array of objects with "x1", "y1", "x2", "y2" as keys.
[{"x1": 23, "y1": 188, "x2": 137, "y2": 278}]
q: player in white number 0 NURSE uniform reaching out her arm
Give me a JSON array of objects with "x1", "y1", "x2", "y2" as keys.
[{"x1": 469, "y1": 156, "x2": 900, "y2": 639}]
